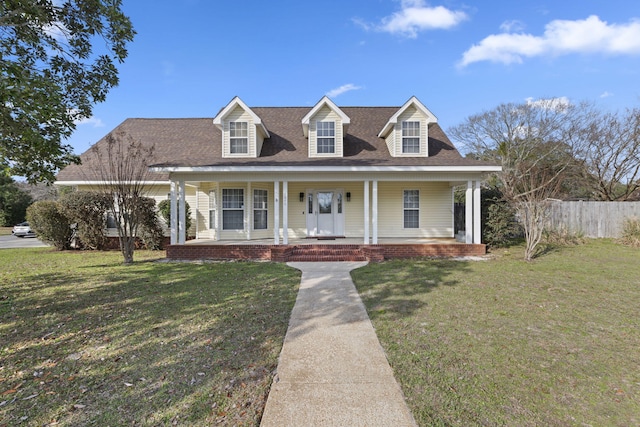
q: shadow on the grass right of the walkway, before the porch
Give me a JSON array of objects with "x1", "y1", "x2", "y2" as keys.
[{"x1": 351, "y1": 259, "x2": 469, "y2": 320}]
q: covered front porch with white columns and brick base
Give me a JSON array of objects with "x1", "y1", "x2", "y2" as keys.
[{"x1": 168, "y1": 170, "x2": 485, "y2": 259}]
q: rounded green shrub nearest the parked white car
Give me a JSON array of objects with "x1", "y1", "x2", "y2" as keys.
[{"x1": 27, "y1": 200, "x2": 73, "y2": 250}]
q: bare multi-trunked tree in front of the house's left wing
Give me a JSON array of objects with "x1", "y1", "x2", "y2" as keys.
[{"x1": 83, "y1": 132, "x2": 154, "y2": 264}]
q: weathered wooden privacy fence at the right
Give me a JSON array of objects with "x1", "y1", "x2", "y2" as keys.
[{"x1": 549, "y1": 201, "x2": 640, "y2": 238}]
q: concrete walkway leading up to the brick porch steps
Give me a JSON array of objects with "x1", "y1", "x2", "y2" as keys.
[{"x1": 260, "y1": 262, "x2": 416, "y2": 427}]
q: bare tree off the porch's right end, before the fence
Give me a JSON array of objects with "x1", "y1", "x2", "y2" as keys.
[{"x1": 448, "y1": 98, "x2": 590, "y2": 260}]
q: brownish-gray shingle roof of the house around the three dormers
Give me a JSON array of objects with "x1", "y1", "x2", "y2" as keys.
[{"x1": 58, "y1": 107, "x2": 493, "y2": 181}]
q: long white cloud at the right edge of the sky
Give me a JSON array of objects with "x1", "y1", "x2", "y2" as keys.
[{"x1": 458, "y1": 15, "x2": 640, "y2": 67}]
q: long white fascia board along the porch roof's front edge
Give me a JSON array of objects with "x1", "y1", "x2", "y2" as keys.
[{"x1": 151, "y1": 166, "x2": 502, "y2": 174}]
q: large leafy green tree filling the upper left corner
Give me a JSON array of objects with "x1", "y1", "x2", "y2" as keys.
[{"x1": 0, "y1": 0, "x2": 135, "y2": 182}]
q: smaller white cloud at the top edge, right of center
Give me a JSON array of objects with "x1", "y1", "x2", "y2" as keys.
[{"x1": 353, "y1": 0, "x2": 468, "y2": 38}]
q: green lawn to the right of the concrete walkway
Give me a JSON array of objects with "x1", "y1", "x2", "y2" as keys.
[{"x1": 353, "y1": 240, "x2": 640, "y2": 426}]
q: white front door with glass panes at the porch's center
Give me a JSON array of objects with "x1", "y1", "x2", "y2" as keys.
[{"x1": 307, "y1": 190, "x2": 344, "y2": 237}]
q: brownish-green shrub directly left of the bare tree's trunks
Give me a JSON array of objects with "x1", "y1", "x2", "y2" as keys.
[{"x1": 59, "y1": 191, "x2": 109, "y2": 250}]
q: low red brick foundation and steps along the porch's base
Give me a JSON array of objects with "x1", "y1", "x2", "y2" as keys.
[{"x1": 167, "y1": 244, "x2": 487, "y2": 262}]
